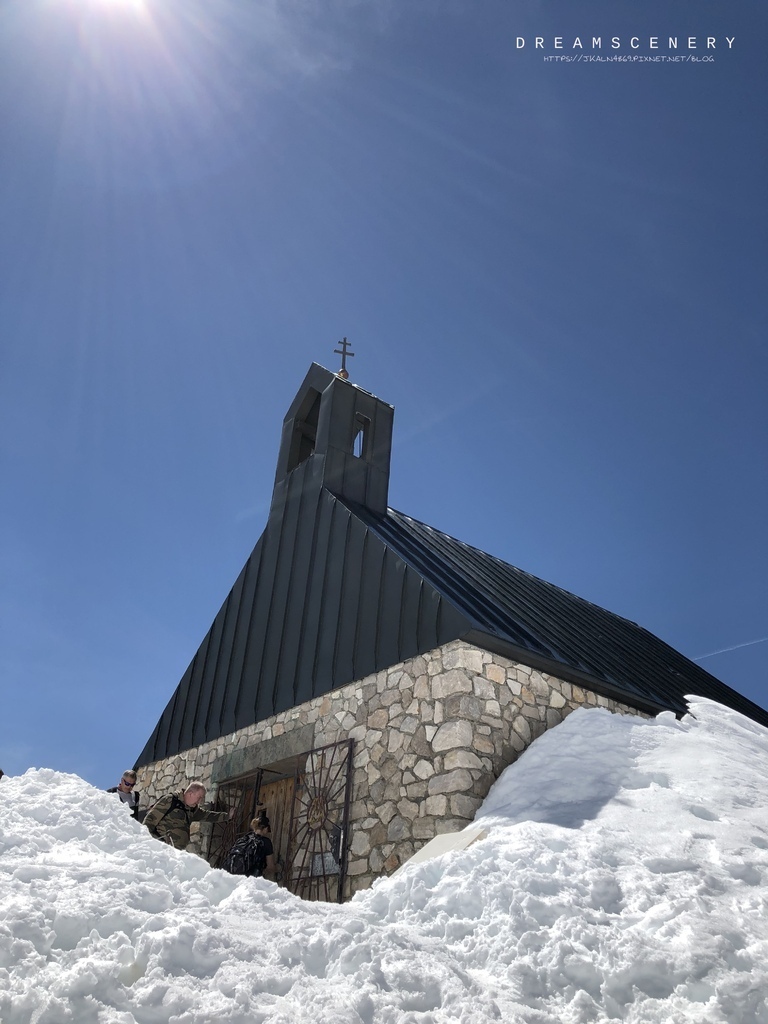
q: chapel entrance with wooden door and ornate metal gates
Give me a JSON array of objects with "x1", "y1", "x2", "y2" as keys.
[{"x1": 208, "y1": 739, "x2": 354, "y2": 903}]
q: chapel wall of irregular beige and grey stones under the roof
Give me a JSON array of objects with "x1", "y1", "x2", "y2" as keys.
[{"x1": 137, "y1": 641, "x2": 640, "y2": 896}]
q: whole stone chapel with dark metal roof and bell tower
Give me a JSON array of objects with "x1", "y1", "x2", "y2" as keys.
[{"x1": 136, "y1": 364, "x2": 768, "y2": 901}]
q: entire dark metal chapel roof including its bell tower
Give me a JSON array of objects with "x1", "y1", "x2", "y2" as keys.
[{"x1": 138, "y1": 364, "x2": 768, "y2": 765}]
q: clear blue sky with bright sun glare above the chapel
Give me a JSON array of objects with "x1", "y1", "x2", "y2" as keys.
[{"x1": 0, "y1": 0, "x2": 768, "y2": 786}]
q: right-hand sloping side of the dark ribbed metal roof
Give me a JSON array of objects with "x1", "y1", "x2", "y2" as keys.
[{"x1": 354, "y1": 507, "x2": 768, "y2": 726}]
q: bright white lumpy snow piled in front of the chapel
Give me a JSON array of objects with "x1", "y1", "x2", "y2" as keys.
[{"x1": 0, "y1": 697, "x2": 768, "y2": 1024}]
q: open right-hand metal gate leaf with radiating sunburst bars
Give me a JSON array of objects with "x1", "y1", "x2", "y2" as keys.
[{"x1": 284, "y1": 739, "x2": 354, "y2": 903}]
